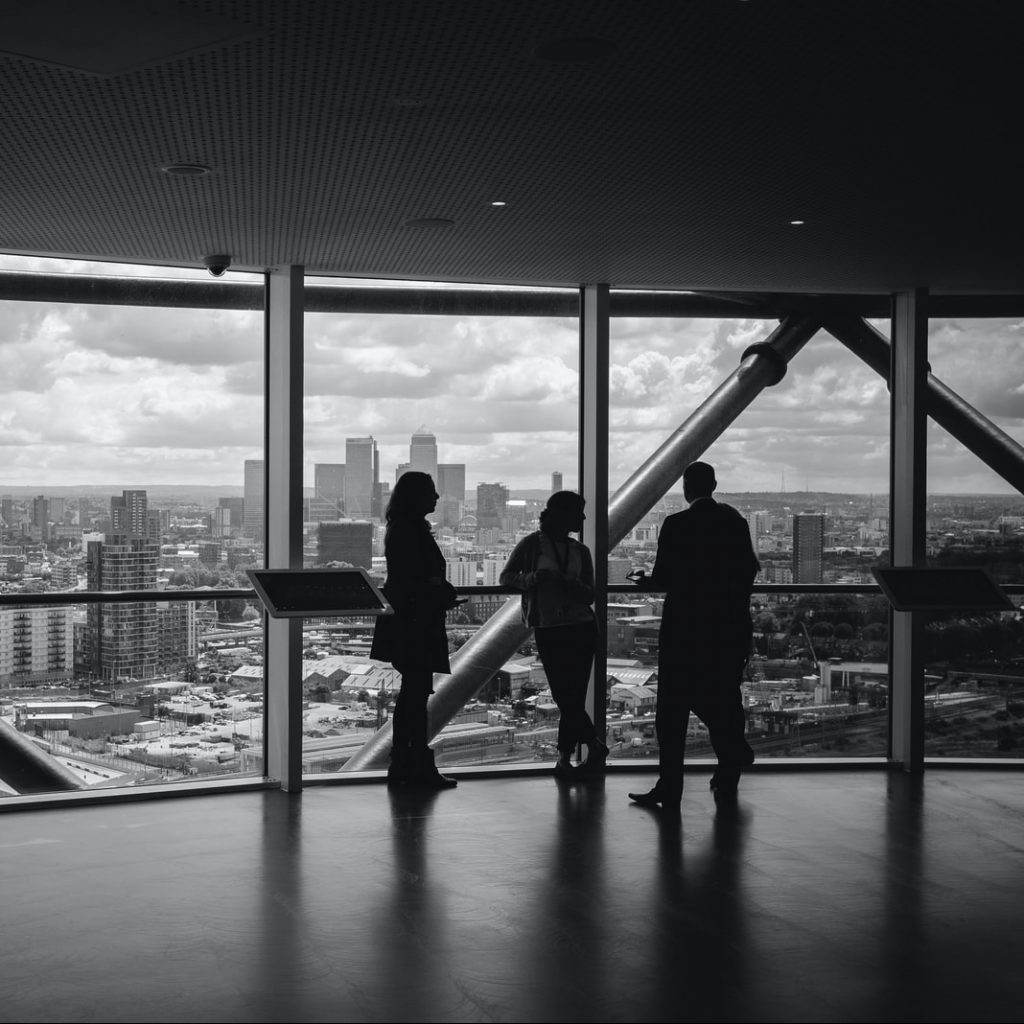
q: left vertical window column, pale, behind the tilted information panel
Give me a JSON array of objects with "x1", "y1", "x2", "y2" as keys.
[{"x1": 264, "y1": 266, "x2": 303, "y2": 793}]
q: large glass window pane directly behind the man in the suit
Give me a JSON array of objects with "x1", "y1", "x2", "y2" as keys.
[{"x1": 607, "y1": 317, "x2": 889, "y2": 758}]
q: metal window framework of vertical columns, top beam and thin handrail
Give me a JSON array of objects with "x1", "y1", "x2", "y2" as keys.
[{"x1": 0, "y1": 266, "x2": 1024, "y2": 792}]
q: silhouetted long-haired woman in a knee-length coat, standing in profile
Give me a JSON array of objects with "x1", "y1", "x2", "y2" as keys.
[{"x1": 370, "y1": 471, "x2": 458, "y2": 790}]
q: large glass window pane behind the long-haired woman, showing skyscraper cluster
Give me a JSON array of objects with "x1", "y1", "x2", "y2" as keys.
[{"x1": 302, "y1": 279, "x2": 579, "y2": 772}]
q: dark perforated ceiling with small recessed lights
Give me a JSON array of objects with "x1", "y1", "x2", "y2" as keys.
[{"x1": 0, "y1": 0, "x2": 1024, "y2": 293}]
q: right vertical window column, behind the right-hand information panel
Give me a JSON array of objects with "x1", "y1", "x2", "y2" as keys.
[{"x1": 889, "y1": 289, "x2": 928, "y2": 771}]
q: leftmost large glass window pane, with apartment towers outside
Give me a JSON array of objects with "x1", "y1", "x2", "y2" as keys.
[{"x1": 0, "y1": 257, "x2": 263, "y2": 792}]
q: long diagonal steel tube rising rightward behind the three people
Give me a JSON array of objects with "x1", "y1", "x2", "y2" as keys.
[{"x1": 344, "y1": 315, "x2": 820, "y2": 771}]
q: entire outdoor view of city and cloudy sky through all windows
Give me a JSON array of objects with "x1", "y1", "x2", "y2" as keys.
[{"x1": 0, "y1": 256, "x2": 1024, "y2": 787}]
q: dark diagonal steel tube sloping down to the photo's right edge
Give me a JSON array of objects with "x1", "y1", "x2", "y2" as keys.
[{"x1": 822, "y1": 315, "x2": 1024, "y2": 494}]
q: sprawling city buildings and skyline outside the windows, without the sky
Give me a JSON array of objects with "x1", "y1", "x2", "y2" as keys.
[{"x1": 0, "y1": 426, "x2": 1024, "y2": 787}]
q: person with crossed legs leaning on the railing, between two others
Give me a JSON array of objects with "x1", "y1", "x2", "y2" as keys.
[{"x1": 501, "y1": 490, "x2": 608, "y2": 777}]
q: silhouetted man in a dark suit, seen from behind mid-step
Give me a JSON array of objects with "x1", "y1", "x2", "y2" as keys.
[{"x1": 629, "y1": 462, "x2": 761, "y2": 813}]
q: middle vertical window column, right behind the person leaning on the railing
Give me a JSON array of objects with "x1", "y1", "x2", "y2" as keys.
[{"x1": 580, "y1": 285, "x2": 608, "y2": 736}]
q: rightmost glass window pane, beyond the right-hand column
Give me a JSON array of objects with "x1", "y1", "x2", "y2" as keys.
[{"x1": 925, "y1": 318, "x2": 1024, "y2": 758}]
